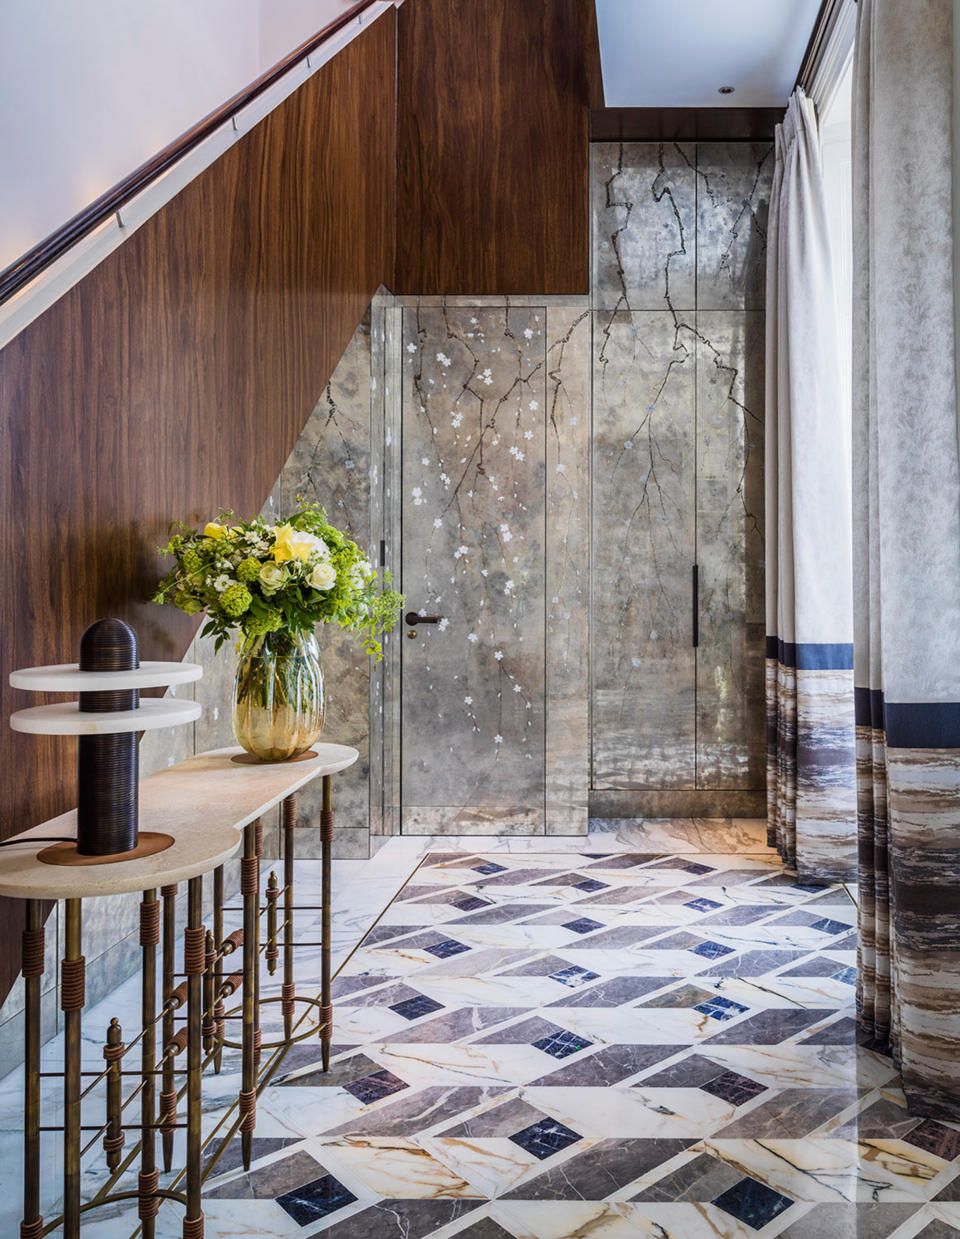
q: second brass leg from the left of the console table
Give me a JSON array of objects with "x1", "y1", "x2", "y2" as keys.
[{"x1": 59, "y1": 900, "x2": 84, "y2": 1239}]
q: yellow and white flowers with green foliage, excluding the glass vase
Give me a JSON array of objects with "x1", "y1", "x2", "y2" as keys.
[{"x1": 154, "y1": 499, "x2": 404, "y2": 659}]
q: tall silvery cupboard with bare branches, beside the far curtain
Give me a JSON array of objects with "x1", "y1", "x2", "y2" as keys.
[{"x1": 591, "y1": 142, "x2": 773, "y2": 815}]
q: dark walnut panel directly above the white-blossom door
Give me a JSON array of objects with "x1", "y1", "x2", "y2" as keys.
[{"x1": 395, "y1": 0, "x2": 588, "y2": 295}]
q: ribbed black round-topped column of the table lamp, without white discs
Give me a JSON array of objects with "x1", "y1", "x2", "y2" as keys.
[{"x1": 77, "y1": 620, "x2": 140, "y2": 856}]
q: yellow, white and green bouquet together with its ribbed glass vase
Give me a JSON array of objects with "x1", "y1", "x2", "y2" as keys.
[{"x1": 154, "y1": 502, "x2": 404, "y2": 761}]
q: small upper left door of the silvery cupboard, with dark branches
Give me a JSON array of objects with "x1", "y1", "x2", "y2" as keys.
[{"x1": 590, "y1": 142, "x2": 696, "y2": 310}]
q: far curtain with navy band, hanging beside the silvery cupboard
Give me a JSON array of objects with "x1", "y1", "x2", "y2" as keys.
[{"x1": 766, "y1": 89, "x2": 856, "y2": 883}]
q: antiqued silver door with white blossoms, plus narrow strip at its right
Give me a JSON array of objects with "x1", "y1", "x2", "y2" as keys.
[{"x1": 385, "y1": 297, "x2": 591, "y2": 834}]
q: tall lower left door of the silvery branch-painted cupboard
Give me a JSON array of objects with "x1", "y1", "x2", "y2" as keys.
[{"x1": 592, "y1": 312, "x2": 696, "y2": 789}]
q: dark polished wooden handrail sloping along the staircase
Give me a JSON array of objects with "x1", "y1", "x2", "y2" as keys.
[{"x1": 0, "y1": 0, "x2": 377, "y2": 305}]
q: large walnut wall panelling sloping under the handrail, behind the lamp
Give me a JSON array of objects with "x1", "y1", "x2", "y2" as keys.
[{"x1": 0, "y1": 10, "x2": 396, "y2": 992}]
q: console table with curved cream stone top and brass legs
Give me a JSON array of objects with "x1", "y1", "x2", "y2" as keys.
[{"x1": 0, "y1": 745, "x2": 358, "y2": 1239}]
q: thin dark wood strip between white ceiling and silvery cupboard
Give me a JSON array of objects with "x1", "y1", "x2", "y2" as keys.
[{"x1": 590, "y1": 102, "x2": 787, "y2": 142}]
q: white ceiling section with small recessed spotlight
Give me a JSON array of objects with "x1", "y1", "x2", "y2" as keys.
[{"x1": 597, "y1": 0, "x2": 820, "y2": 108}]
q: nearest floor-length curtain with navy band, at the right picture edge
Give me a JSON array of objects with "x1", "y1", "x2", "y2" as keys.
[{"x1": 853, "y1": 0, "x2": 960, "y2": 1119}]
